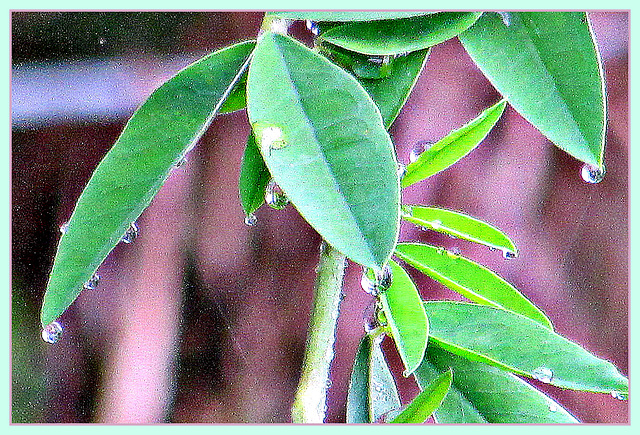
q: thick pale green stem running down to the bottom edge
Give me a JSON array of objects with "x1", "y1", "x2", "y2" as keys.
[{"x1": 291, "y1": 241, "x2": 345, "y2": 423}]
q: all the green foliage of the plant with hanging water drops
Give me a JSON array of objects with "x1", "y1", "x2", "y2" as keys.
[{"x1": 41, "y1": 11, "x2": 628, "y2": 423}]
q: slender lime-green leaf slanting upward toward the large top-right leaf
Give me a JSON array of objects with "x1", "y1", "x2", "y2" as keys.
[{"x1": 402, "y1": 100, "x2": 507, "y2": 187}]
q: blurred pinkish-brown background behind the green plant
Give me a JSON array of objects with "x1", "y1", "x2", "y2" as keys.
[{"x1": 11, "y1": 11, "x2": 629, "y2": 423}]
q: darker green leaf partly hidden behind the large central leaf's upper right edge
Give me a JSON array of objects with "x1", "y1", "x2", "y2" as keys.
[{"x1": 358, "y1": 49, "x2": 429, "y2": 129}]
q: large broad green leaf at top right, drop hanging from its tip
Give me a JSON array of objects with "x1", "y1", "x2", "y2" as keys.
[{"x1": 459, "y1": 12, "x2": 606, "y2": 166}]
